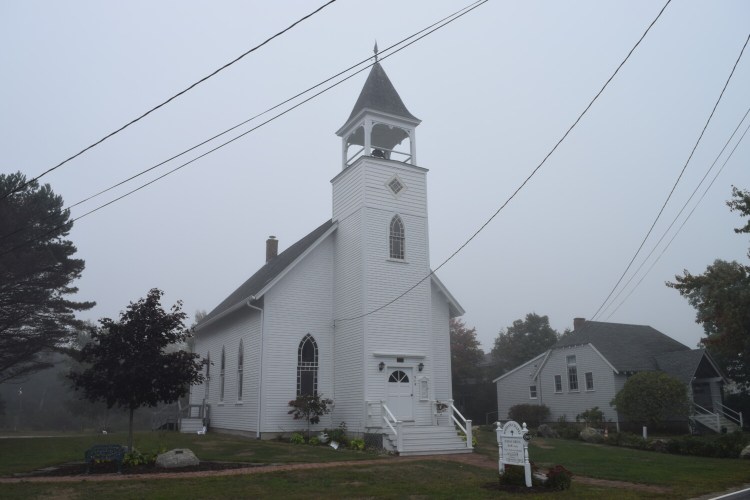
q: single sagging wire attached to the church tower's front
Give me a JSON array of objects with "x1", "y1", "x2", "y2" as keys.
[{"x1": 334, "y1": 0, "x2": 672, "y2": 326}]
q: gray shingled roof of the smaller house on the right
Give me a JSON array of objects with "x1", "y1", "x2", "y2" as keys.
[{"x1": 554, "y1": 321, "x2": 692, "y2": 372}]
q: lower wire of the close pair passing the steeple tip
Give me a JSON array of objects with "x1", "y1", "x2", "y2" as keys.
[{"x1": 0, "y1": 0, "x2": 490, "y2": 257}]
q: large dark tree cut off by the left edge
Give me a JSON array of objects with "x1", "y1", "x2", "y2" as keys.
[{"x1": 0, "y1": 173, "x2": 94, "y2": 382}]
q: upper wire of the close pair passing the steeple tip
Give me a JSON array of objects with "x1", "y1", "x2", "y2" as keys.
[{"x1": 0, "y1": 0, "x2": 488, "y2": 241}]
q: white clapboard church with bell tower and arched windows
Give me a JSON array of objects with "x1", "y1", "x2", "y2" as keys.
[{"x1": 188, "y1": 61, "x2": 471, "y2": 455}]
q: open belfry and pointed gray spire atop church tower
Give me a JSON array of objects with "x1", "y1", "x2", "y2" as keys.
[{"x1": 336, "y1": 60, "x2": 420, "y2": 168}]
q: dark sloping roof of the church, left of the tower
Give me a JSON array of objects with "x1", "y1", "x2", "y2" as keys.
[{"x1": 198, "y1": 220, "x2": 333, "y2": 327}]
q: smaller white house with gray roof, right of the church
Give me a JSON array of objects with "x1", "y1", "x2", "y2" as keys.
[{"x1": 494, "y1": 318, "x2": 742, "y2": 431}]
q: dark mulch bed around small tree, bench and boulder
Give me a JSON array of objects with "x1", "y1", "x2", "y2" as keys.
[{"x1": 14, "y1": 462, "x2": 267, "y2": 477}]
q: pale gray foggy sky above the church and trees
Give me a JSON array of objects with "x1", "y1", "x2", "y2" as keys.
[{"x1": 0, "y1": 0, "x2": 750, "y2": 348}]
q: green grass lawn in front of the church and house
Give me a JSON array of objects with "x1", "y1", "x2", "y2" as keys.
[{"x1": 0, "y1": 431, "x2": 750, "y2": 500}]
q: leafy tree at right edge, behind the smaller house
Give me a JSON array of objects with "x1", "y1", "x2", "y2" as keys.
[{"x1": 667, "y1": 188, "x2": 750, "y2": 391}]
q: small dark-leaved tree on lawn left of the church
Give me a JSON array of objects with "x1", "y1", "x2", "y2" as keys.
[{"x1": 70, "y1": 288, "x2": 203, "y2": 450}]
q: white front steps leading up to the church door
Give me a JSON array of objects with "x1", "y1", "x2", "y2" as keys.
[{"x1": 384, "y1": 425, "x2": 472, "y2": 456}]
